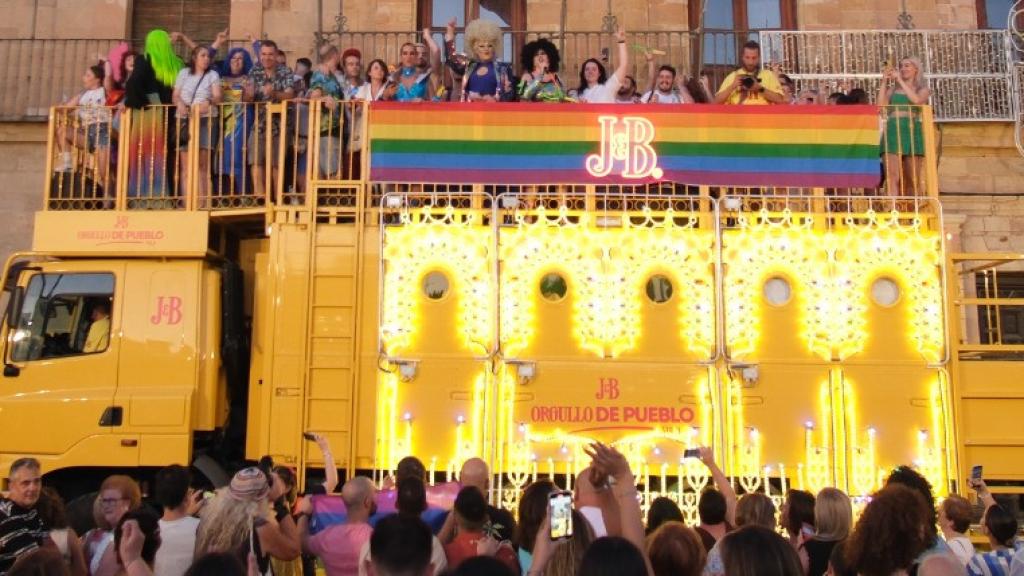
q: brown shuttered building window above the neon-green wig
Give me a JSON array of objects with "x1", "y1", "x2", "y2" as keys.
[{"x1": 131, "y1": 0, "x2": 231, "y2": 47}]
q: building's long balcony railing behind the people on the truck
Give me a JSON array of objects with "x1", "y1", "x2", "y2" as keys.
[{"x1": 6, "y1": 30, "x2": 1021, "y2": 122}]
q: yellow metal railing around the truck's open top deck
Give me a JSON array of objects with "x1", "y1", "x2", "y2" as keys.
[{"x1": 44, "y1": 100, "x2": 937, "y2": 215}]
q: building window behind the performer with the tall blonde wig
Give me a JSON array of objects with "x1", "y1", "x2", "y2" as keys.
[{"x1": 418, "y1": 0, "x2": 526, "y2": 61}]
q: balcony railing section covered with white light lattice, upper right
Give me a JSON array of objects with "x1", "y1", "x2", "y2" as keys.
[{"x1": 761, "y1": 30, "x2": 1018, "y2": 122}]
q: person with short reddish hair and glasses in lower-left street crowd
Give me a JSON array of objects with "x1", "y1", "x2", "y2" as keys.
[{"x1": 82, "y1": 475, "x2": 142, "y2": 576}]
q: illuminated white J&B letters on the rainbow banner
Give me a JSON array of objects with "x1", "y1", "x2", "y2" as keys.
[{"x1": 587, "y1": 116, "x2": 665, "y2": 179}]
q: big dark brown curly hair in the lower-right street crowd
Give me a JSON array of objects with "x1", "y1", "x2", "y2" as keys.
[{"x1": 846, "y1": 483, "x2": 934, "y2": 576}]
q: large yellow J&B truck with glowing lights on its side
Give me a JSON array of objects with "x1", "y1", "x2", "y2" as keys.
[{"x1": 0, "y1": 102, "x2": 1024, "y2": 517}]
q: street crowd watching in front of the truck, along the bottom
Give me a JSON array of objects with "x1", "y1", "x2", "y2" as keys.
[{"x1": 0, "y1": 436, "x2": 1024, "y2": 576}]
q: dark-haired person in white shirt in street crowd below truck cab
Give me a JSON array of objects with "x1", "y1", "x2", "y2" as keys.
[{"x1": 154, "y1": 464, "x2": 203, "y2": 576}]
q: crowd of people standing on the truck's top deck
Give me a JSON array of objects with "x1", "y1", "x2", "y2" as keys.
[{"x1": 54, "y1": 19, "x2": 930, "y2": 197}]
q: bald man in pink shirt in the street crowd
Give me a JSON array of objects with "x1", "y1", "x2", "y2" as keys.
[{"x1": 299, "y1": 476, "x2": 377, "y2": 576}]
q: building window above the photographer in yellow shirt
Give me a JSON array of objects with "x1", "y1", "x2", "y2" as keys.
[{"x1": 689, "y1": 0, "x2": 797, "y2": 69}]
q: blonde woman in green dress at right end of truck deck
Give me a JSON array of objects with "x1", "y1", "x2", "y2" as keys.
[{"x1": 878, "y1": 57, "x2": 932, "y2": 196}]
